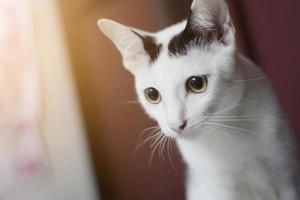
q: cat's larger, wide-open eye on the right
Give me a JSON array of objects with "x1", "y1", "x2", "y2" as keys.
[{"x1": 186, "y1": 75, "x2": 207, "y2": 93}]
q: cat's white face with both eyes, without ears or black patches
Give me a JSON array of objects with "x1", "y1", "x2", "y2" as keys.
[{"x1": 134, "y1": 40, "x2": 234, "y2": 137}]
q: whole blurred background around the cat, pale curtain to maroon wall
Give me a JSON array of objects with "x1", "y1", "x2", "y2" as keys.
[{"x1": 0, "y1": 0, "x2": 300, "y2": 200}]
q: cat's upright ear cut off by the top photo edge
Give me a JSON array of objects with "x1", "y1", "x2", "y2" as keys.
[{"x1": 188, "y1": 0, "x2": 235, "y2": 44}]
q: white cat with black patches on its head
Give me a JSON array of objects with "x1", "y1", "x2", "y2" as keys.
[{"x1": 98, "y1": 0, "x2": 300, "y2": 200}]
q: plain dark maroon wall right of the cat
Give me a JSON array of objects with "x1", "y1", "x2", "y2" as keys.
[{"x1": 236, "y1": 0, "x2": 300, "y2": 144}]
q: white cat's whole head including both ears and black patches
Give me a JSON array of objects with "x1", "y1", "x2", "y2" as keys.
[{"x1": 98, "y1": 0, "x2": 241, "y2": 138}]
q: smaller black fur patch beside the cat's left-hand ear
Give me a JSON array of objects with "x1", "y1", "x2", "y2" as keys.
[{"x1": 132, "y1": 31, "x2": 162, "y2": 63}]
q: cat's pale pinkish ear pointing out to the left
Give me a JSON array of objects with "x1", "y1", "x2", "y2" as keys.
[{"x1": 97, "y1": 19, "x2": 148, "y2": 73}]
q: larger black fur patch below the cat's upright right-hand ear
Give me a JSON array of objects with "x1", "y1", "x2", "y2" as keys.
[{"x1": 168, "y1": 14, "x2": 223, "y2": 56}]
